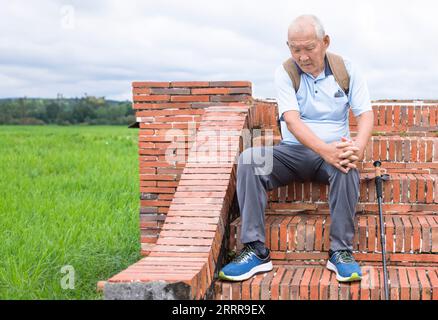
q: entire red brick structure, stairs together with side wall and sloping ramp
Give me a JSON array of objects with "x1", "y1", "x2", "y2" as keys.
[{"x1": 99, "y1": 81, "x2": 438, "y2": 300}]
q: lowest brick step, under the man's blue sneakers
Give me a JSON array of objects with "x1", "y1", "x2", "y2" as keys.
[{"x1": 214, "y1": 266, "x2": 438, "y2": 300}]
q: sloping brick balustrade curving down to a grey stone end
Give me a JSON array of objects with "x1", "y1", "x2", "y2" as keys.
[{"x1": 103, "y1": 106, "x2": 249, "y2": 299}]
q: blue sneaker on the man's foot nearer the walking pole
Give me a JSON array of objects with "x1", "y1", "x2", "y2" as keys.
[{"x1": 327, "y1": 250, "x2": 362, "y2": 282}]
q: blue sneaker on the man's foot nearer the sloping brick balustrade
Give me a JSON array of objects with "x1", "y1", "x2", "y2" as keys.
[{"x1": 219, "y1": 245, "x2": 272, "y2": 281}]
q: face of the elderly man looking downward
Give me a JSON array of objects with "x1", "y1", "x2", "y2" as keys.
[{"x1": 287, "y1": 30, "x2": 330, "y2": 77}]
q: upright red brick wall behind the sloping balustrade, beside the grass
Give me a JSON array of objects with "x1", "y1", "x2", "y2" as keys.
[{"x1": 132, "y1": 81, "x2": 253, "y2": 255}]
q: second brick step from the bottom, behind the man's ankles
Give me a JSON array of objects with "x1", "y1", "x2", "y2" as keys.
[{"x1": 229, "y1": 213, "x2": 438, "y2": 263}]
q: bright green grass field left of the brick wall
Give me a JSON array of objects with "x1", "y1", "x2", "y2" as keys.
[{"x1": 0, "y1": 126, "x2": 140, "y2": 299}]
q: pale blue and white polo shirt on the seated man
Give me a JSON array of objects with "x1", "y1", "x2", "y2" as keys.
[{"x1": 275, "y1": 58, "x2": 372, "y2": 144}]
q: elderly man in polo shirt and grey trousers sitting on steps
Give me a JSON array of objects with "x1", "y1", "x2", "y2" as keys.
[{"x1": 219, "y1": 15, "x2": 373, "y2": 282}]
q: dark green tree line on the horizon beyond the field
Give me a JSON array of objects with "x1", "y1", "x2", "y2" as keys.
[{"x1": 0, "y1": 96, "x2": 135, "y2": 125}]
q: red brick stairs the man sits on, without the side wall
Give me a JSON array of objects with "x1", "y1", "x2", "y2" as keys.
[{"x1": 215, "y1": 104, "x2": 438, "y2": 300}]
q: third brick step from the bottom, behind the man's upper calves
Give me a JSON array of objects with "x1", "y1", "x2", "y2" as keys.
[{"x1": 269, "y1": 173, "x2": 438, "y2": 206}]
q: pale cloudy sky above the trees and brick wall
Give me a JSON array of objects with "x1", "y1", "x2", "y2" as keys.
[{"x1": 0, "y1": 0, "x2": 438, "y2": 100}]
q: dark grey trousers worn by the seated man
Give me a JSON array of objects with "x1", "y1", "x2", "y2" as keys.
[{"x1": 237, "y1": 142, "x2": 360, "y2": 251}]
